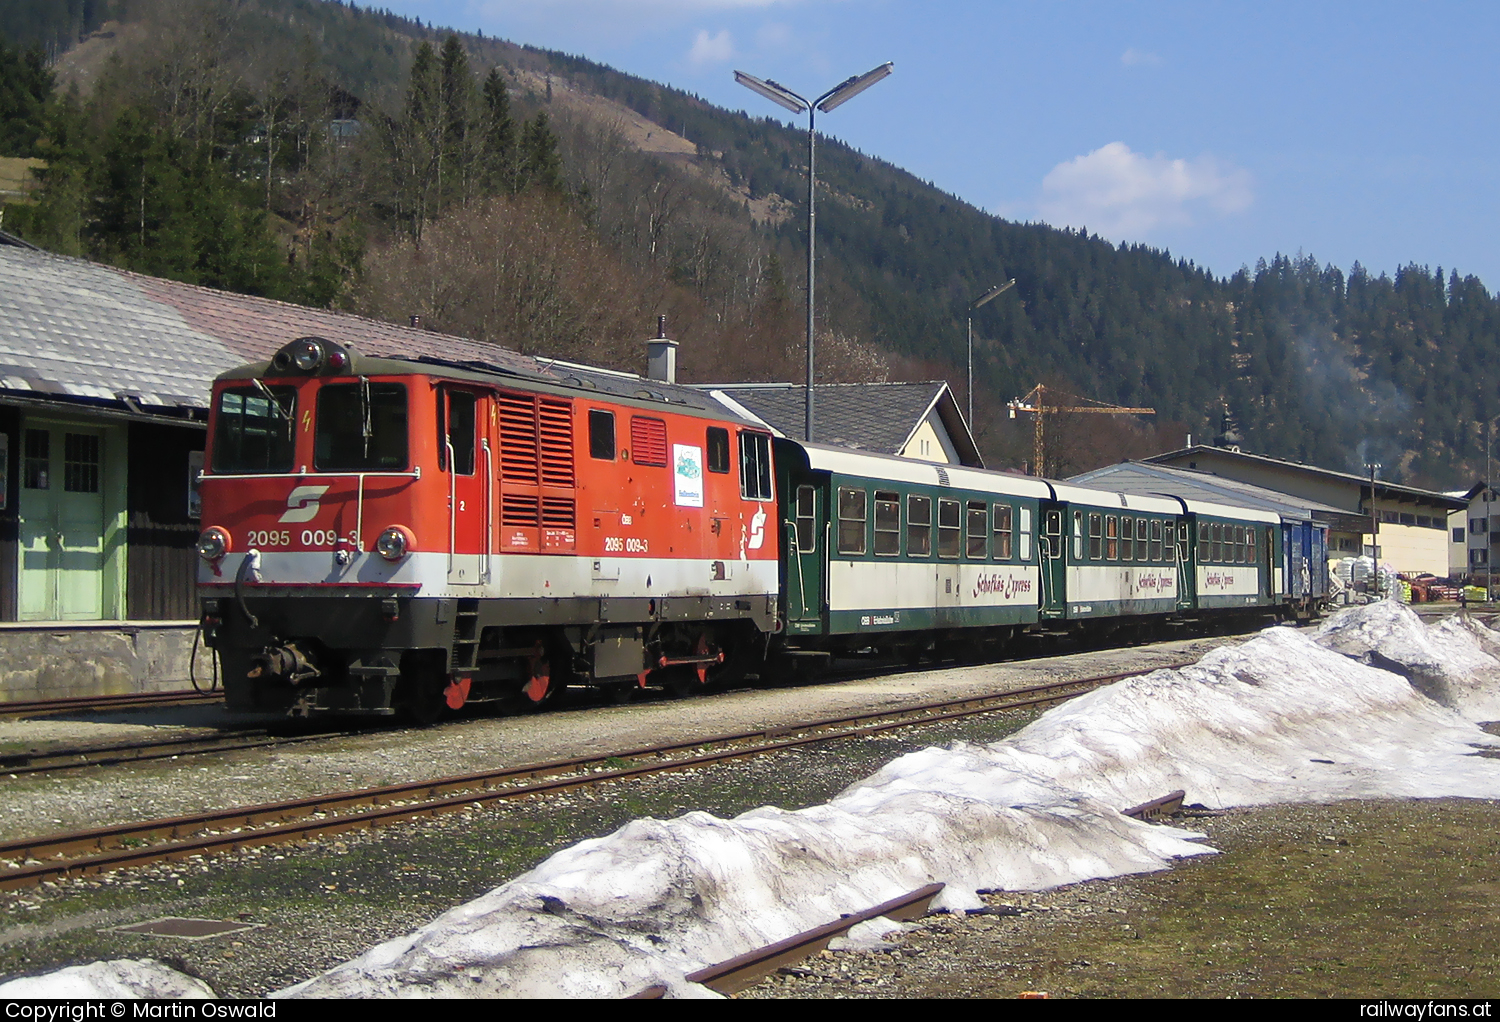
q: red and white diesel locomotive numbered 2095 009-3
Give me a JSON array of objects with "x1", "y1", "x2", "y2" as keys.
[{"x1": 198, "y1": 338, "x2": 779, "y2": 719}]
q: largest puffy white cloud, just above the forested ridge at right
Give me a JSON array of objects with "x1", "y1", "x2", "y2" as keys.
[{"x1": 1038, "y1": 143, "x2": 1254, "y2": 240}]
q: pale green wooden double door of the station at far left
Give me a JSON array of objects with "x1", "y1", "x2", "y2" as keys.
[{"x1": 18, "y1": 423, "x2": 105, "y2": 621}]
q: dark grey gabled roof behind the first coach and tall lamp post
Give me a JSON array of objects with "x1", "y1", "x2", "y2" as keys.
[{"x1": 699, "y1": 383, "x2": 947, "y2": 455}]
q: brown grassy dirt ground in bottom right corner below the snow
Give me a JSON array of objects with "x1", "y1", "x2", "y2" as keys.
[{"x1": 740, "y1": 798, "x2": 1500, "y2": 998}]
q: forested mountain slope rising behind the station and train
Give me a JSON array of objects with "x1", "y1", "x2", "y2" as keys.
[{"x1": 0, "y1": 0, "x2": 1500, "y2": 488}]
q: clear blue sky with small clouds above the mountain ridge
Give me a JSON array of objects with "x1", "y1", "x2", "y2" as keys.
[{"x1": 366, "y1": 0, "x2": 1500, "y2": 290}]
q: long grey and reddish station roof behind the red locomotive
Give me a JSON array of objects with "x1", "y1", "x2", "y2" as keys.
[{"x1": 0, "y1": 245, "x2": 725, "y2": 414}]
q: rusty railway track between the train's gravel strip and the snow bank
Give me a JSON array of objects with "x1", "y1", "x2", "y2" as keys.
[{"x1": 0, "y1": 662, "x2": 1187, "y2": 890}]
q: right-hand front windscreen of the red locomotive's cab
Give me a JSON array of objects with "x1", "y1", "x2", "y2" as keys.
[{"x1": 312, "y1": 380, "x2": 407, "y2": 471}]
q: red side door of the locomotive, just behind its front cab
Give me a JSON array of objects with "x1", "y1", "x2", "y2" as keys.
[{"x1": 438, "y1": 387, "x2": 495, "y2": 585}]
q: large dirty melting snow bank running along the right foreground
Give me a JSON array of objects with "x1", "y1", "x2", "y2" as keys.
[{"x1": 282, "y1": 603, "x2": 1500, "y2": 996}]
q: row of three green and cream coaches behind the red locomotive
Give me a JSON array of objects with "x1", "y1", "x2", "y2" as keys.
[{"x1": 776, "y1": 440, "x2": 1284, "y2": 651}]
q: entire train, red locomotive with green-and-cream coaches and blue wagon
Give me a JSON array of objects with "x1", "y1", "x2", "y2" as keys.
[{"x1": 200, "y1": 338, "x2": 1326, "y2": 720}]
